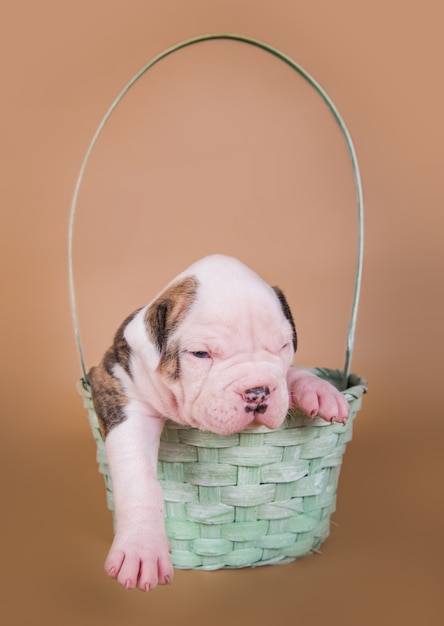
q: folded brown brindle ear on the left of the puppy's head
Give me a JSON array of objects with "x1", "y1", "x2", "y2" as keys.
[{"x1": 145, "y1": 276, "x2": 199, "y2": 353}]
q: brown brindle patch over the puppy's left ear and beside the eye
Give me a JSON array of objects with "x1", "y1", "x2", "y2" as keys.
[{"x1": 145, "y1": 276, "x2": 199, "y2": 380}]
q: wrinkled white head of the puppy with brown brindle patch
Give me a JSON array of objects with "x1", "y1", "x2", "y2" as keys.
[{"x1": 146, "y1": 257, "x2": 296, "y2": 434}]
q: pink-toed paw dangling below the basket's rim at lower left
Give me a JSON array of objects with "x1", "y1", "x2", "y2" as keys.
[{"x1": 105, "y1": 531, "x2": 174, "y2": 591}]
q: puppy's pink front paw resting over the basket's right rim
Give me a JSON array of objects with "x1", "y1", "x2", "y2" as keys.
[{"x1": 287, "y1": 367, "x2": 349, "y2": 424}]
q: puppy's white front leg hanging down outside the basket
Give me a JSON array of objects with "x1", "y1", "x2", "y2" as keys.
[{"x1": 105, "y1": 403, "x2": 173, "y2": 591}]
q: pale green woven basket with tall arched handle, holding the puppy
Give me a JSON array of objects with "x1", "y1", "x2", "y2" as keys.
[{"x1": 69, "y1": 34, "x2": 367, "y2": 570}]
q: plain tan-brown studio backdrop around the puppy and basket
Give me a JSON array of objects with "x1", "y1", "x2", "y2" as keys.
[{"x1": 0, "y1": 0, "x2": 444, "y2": 626}]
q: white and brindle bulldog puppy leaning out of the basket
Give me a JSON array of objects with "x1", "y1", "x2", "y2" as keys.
[{"x1": 88, "y1": 255, "x2": 348, "y2": 591}]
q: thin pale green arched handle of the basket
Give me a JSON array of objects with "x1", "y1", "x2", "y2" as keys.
[{"x1": 68, "y1": 34, "x2": 364, "y2": 388}]
